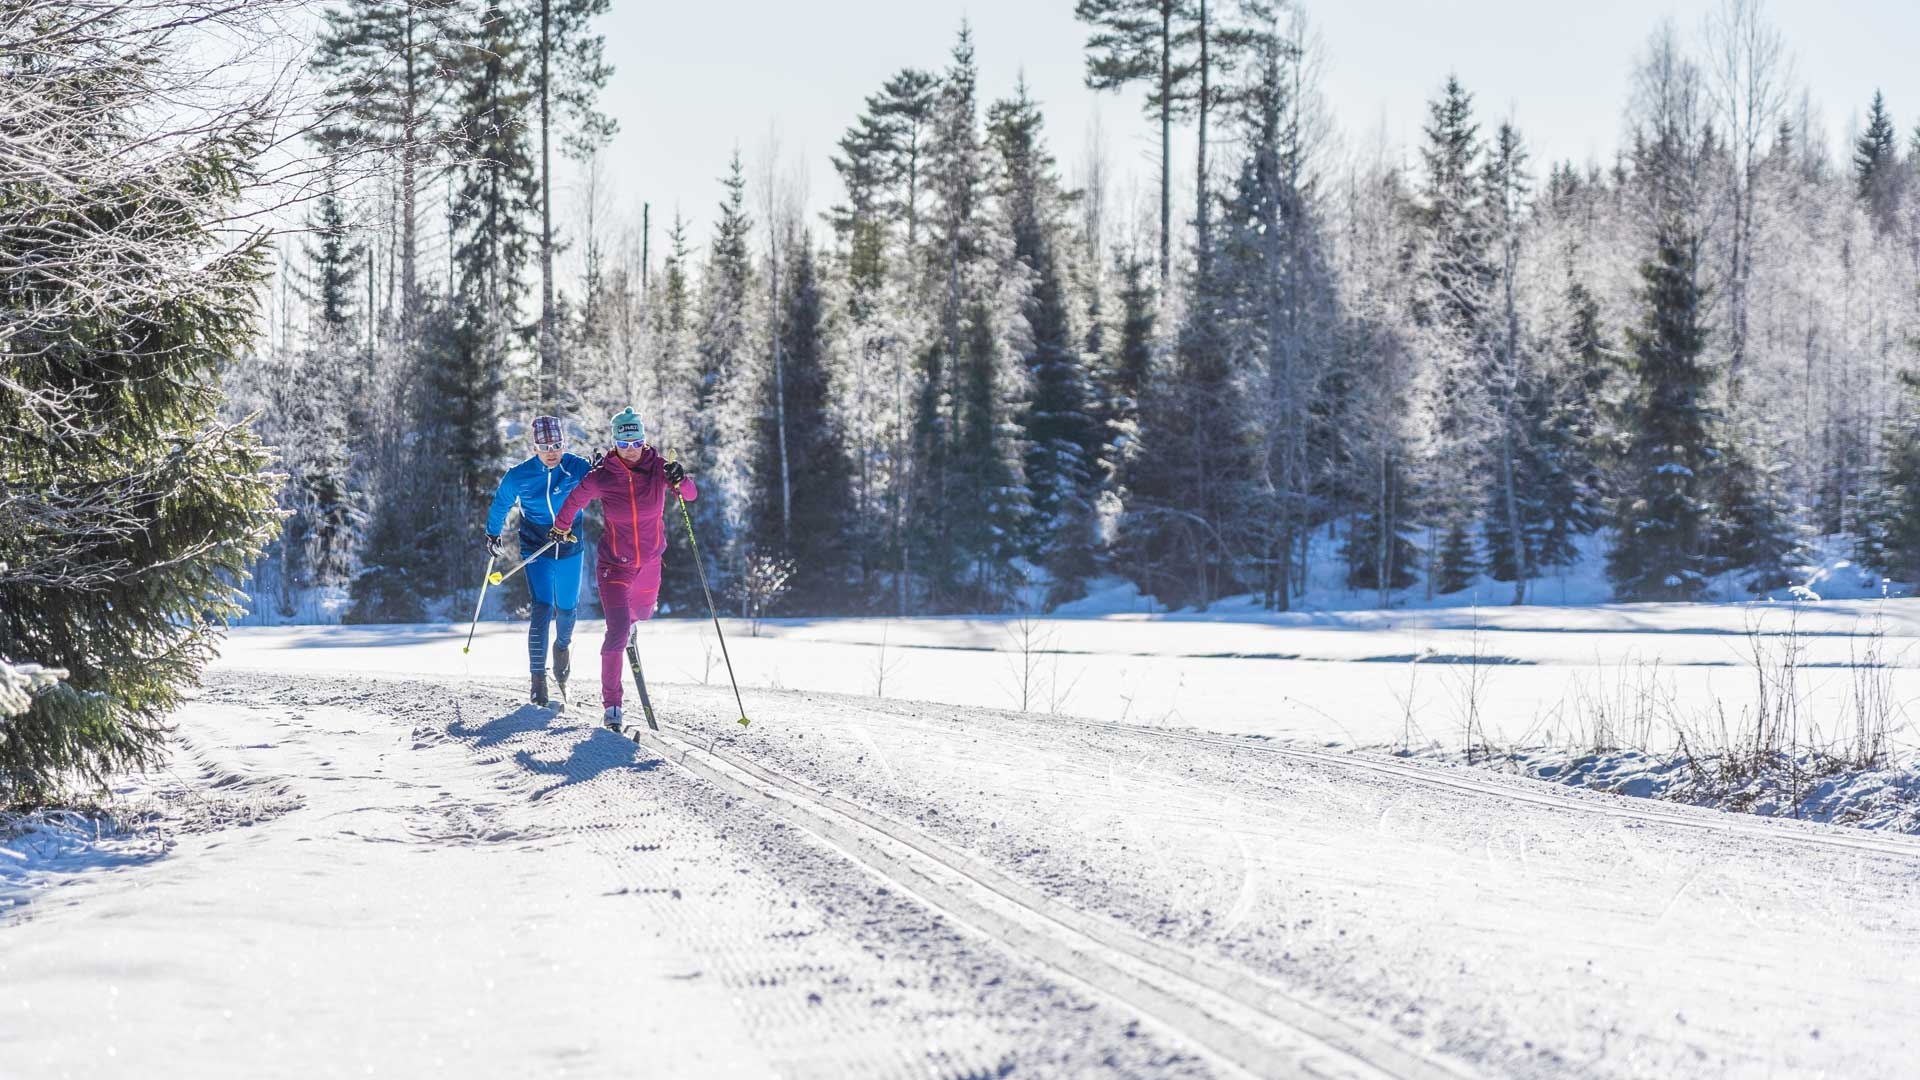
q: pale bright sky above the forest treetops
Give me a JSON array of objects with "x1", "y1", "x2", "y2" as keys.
[{"x1": 583, "y1": 0, "x2": 1920, "y2": 252}]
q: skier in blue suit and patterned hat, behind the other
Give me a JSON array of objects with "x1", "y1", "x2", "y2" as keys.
[{"x1": 486, "y1": 417, "x2": 593, "y2": 705}]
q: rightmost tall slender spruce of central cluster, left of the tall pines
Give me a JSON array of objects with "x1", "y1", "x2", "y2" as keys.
[{"x1": 987, "y1": 83, "x2": 1100, "y2": 605}]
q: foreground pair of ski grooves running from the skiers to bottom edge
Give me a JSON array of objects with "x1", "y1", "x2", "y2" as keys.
[{"x1": 630, "y1": 724, "x2": 1467, "y2": 1080}]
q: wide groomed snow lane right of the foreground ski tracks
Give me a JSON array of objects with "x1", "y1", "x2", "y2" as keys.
[{"x1": 633, "y1": 688, "x2": 1920, "y2": 1076}]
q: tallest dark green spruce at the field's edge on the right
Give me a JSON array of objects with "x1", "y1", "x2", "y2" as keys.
[{"x1": 1607, "y1": 217, "x2": 1716, "y2": 600}]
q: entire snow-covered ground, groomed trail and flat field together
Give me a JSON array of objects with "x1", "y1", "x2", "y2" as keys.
[{"x1": 0, "y1": 601, "x2": 1920, "y2": 1076}]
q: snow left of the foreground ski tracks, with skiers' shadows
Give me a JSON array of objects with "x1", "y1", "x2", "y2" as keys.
[{"x1": 0, "y1": 675, "x2": 1206, "y2": 1078}]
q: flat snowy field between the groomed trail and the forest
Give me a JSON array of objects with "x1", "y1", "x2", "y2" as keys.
[{"x1": 221, "y1": 600, "x2": 1920, "y2": 755}]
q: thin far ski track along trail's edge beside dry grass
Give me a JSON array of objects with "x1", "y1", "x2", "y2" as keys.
[{"x1": 817, "y1": 701, "x2": 1920, "y2": 859}]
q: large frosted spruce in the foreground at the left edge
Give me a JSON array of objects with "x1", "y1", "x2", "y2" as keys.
[{"x1": 0, "y1": 0, "x2": 276, "y2": 801}]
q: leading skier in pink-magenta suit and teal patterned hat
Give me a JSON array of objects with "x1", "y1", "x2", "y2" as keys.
[{"x1": 553, "y1": 409, "x2": 699, "y2": 730}]
